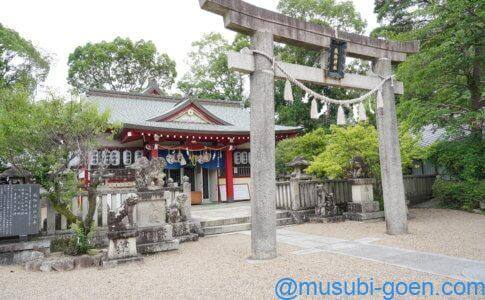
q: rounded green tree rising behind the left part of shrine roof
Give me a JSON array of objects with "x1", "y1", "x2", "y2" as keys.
[{"x1": 67, "y1": 37, "x2": 177, "y2": 93}]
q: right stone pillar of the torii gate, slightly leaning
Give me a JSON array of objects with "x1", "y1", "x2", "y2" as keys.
[{"x1": 374, "y1": 58, "x2": 408, "y2": 234}]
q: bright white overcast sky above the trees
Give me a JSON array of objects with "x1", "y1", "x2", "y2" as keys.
[{"x1": 0, "y1": 0, "x2": 377, "y2": 98}]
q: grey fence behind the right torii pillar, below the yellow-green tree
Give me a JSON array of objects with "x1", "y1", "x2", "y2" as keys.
[{"x1": 276, "y1": 175, "x2": 436, "y2": 210}]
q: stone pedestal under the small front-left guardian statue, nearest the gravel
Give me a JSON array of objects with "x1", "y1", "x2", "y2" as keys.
[{"x1": 101, "y1": 229, "x2": 143, "y2": 268}]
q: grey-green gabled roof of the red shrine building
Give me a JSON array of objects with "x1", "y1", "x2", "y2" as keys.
[{"x1": 86, "y1": 90, "x2": 301, "y2": 134}]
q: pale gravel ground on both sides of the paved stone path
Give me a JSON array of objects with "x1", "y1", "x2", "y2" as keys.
[{"x1": 0, "y1": 210, "x2": 485, "y2": 299}]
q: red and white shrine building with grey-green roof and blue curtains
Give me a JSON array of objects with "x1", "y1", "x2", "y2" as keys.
[{"x1": 86, "y1": 86, "x2": 301, "y2": 204}]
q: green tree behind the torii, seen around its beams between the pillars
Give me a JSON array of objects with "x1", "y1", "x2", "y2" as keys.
[{"x1": 275, "y1": 0, "x2": 367, "y2": 132}]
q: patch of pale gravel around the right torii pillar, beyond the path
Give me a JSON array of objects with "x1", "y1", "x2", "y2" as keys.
[{"x1": 295, "y1": 209, "x2": 485, "y2": 261}]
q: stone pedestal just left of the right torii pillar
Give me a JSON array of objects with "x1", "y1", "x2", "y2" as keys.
[{"x1": 345, "y1": 178, "x2": 384, "y2": 221}]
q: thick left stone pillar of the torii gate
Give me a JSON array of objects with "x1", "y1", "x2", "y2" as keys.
[{"x1": 249, "y1": 31, "x2": 276, "y2": 260}]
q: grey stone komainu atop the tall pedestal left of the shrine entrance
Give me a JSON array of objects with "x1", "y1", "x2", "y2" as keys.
[{"x1": 129, "y1": 157, "x2": 165, "y2": 190}]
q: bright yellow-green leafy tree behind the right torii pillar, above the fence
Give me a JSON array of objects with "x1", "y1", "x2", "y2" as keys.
[{"x1": 307, "y1": 123, "x2": 422, "y2": 179}]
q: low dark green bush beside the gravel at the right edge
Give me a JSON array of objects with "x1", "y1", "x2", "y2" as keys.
[{"x1": 433, "y1": 178, "x2": 485, "y2": 211}]
